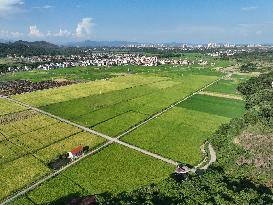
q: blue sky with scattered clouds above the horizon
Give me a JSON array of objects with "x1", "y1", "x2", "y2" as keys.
[{"x1": 0, "y1": 0, "x2": 273, "y2": 43}]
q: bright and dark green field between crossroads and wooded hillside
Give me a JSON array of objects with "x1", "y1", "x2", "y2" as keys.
[{"x1": 123, "y1": 95, "x2": 244, "y2": 164}]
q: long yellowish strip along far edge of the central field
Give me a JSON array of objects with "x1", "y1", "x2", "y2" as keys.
[{"x1": 14, "y1": 75, "x2": 166, "y2": 106}]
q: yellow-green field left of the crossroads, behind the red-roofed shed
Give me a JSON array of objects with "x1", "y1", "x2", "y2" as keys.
[{"x1": 0, "y1": 99, "x2": 104, "y2": 200}]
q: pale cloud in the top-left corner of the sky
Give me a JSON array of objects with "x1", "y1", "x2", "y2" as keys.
[{"x1": 0, "y1": 0, "x2": 24, "y2": 16}]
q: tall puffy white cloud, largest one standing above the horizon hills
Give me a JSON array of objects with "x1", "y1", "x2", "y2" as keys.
[{"x1": 75, "y1": 17, "x2": 95, "y2": 38}]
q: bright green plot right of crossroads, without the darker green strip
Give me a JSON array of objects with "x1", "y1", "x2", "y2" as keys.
[{"x1": 122, "y1": 107, "x2": 229, "y2": 165}]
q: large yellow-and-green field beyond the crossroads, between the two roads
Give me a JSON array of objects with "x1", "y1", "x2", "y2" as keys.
[{"x1": 20, "y1": 75, "x2": 218, "y2": 136}]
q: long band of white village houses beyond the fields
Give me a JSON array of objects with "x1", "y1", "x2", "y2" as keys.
[{"x1": 7, "y1": 53, "x2": 208, "y2": 72}]
